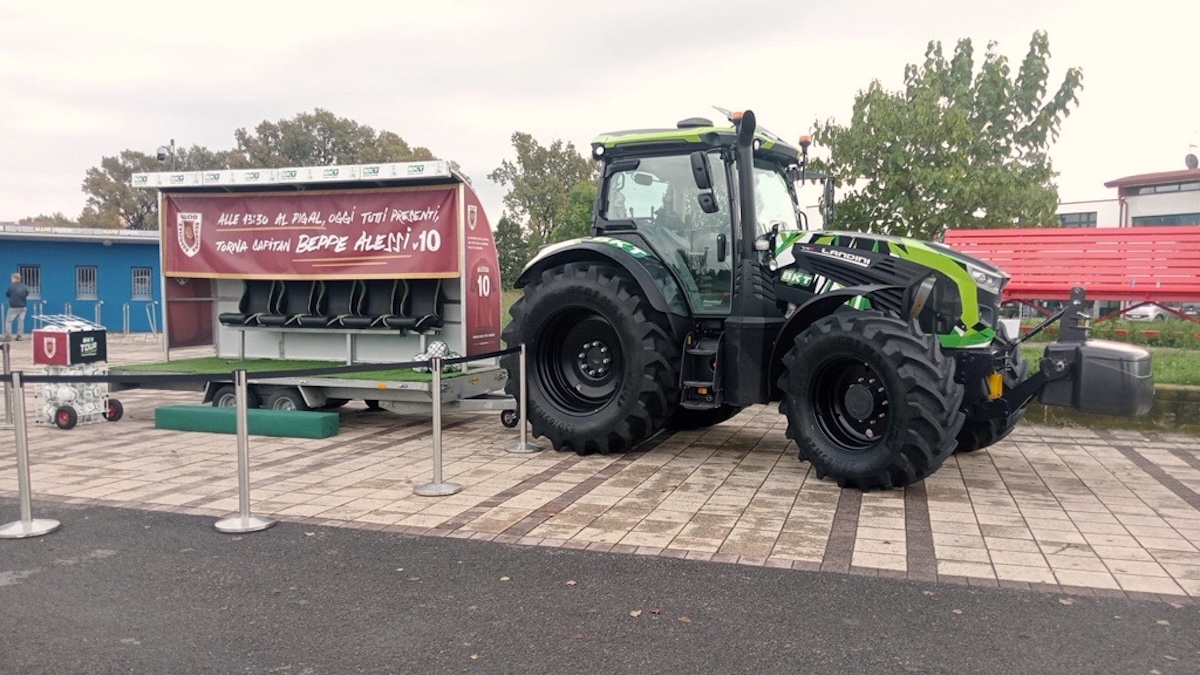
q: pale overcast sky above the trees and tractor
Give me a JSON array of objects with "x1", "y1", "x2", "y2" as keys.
[{"x1": 0, "y1": 0, "x2": 1200, "y2": 222}]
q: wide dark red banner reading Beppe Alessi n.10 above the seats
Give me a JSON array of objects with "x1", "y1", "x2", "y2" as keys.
[{"x1": 162, "y1": 187, "x2": 460, "y2": 279}]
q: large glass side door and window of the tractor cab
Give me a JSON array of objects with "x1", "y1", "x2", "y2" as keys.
[{"x1": 600, "y1": 151, "x2": 732, "y2": 313}]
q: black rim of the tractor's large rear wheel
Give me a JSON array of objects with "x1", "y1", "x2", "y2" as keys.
[{"x1": 534, "y1": 310, "x2": 624, "y2": 413}]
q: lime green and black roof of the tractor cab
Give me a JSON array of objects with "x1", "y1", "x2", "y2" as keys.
[{"x1": 592, "y1": 118, "x2": 800, "y2": 163}]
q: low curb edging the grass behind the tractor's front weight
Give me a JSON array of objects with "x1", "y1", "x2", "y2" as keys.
[{"x1": 1025, "y1": 384, "x2": 1200, "y2": 435}]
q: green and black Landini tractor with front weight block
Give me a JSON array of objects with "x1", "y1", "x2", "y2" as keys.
[{"x1": 503, "y1": 110, "x2": 1153, "y2": 490}]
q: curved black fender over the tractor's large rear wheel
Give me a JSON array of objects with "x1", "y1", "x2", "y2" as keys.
[{"x1": 512, "y1": 237, "x2": 691, "y2": 318}]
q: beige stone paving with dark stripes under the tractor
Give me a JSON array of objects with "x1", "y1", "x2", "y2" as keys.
[{"x1": 0, "y1": 336, "x2": 1200, "y2": 603}]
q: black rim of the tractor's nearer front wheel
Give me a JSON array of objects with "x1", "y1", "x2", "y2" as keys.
[{"x1": 811, "y1": 359, "x2": 890, "y2": 452}]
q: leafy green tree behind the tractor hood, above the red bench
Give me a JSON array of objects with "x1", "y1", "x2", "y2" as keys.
[{"x1": 814, "y1": 31, "x2": 1082, "y2": 239}]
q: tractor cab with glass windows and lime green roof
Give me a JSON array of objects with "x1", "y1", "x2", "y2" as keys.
[{"x1": 592, "y1": 112, "x2": 805, "y2": 317}]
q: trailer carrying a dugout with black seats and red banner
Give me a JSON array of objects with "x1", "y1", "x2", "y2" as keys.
[{"x1": 126, "y1": 160, "x2": 515, "y2": 423}]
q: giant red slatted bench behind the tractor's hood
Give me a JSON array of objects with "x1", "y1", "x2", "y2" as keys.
[{"x1": 944, "y1": 226, "x2": 1200, "y2": 318}]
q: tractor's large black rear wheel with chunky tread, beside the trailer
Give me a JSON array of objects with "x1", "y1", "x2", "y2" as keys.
[{"x1": 500, "y1": 261, "x2": 680, "y2": 455}]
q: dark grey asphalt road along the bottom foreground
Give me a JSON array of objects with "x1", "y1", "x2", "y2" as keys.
[{"x1": 0, "y1": 498, "x2": 1200, "y2": 674}]
